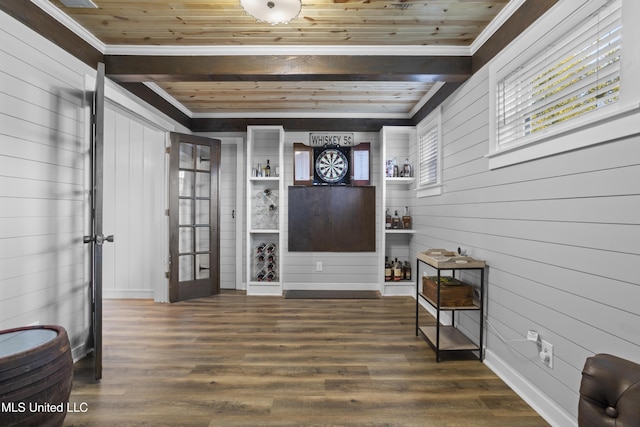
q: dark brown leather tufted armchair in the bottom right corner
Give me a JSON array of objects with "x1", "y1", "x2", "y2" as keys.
[{"x1": 578, "y1": 354, "x2": 640, "y2": 427}]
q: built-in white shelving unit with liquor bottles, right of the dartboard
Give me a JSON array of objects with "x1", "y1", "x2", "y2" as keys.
[{"x1": 378, "y1": 126, "x2": 417, "y2": 295}]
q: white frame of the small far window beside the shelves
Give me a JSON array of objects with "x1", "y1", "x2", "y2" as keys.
[{"x1": 416, "y1": 106, "x2": 443, "y2": 198}]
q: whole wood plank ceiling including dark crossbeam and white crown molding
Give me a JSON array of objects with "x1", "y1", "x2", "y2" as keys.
[{"x1": 1, "y1": 0, "x2": 555, "y2": 130}]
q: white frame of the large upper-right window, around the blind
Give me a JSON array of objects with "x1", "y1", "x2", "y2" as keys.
[{"x1": 487, "y1": 0, "x2": 640, "y2": 169}]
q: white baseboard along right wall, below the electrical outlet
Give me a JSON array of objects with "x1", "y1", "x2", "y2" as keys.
[{"x1": 484, "y1": 349, "x2": 578, "y2": 427}]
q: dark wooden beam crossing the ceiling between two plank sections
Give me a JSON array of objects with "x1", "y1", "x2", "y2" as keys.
[{"x1": 105, "y1": 55, "x2": 471, "y2": 82}]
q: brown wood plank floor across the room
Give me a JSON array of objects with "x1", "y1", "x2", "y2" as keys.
[{"x1": 64, "y1": 291, "x2": 548, "y2": 427}]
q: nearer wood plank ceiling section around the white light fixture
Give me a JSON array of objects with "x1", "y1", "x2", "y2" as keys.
[{"x1": 51, "y1": 0, "x2": 508, "y2": 46}]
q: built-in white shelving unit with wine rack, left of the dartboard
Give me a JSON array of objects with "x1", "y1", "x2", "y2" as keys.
[{"x1": 246, "y1": 126, "x2": 285, "y2": 295}]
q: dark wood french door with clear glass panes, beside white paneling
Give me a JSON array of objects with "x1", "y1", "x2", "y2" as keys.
[{"x1": 169, "y1": 133, "x2": 221, "y2": 302}]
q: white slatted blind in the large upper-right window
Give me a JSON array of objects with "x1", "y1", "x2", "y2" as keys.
[{"x1": 496, "y1": 0, "x2": 622, "y2": 147}]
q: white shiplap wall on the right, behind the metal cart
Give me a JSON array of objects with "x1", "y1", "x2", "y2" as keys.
[{"x1": 414, "y1": 67, "x2": 640, "y2": 425}]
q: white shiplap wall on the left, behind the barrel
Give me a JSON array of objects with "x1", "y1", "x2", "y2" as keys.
[{"x1": 0, "y1": 12, "x2": 94, "y2": 356}]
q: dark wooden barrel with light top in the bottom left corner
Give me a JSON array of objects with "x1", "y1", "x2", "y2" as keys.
[{"x1": 0, "y1": 325, "x2": 73, "y2": 426}]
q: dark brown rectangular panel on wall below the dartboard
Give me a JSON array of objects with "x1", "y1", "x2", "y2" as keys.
[{"x1": 288, "y1": 186, "x2": 376, "y2": 252}]
